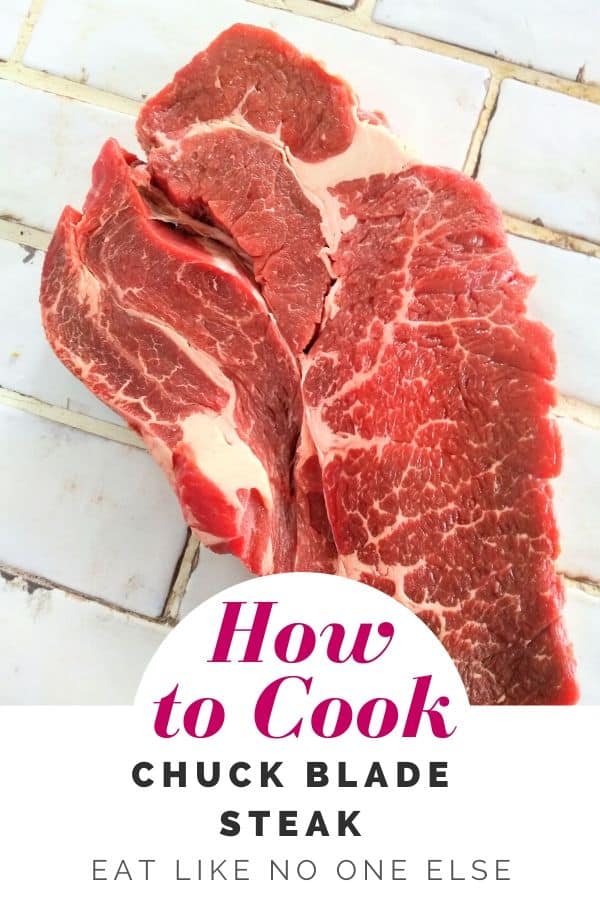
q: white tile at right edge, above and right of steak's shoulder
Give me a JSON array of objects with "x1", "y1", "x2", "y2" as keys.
[{"x1": 479, "y1": 80, "x2": 600, "y2": 240}]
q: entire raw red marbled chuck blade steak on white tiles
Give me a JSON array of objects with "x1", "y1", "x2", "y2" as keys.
[{"x1": 42, "y1": 25, "x2": 577, "y2": 703}]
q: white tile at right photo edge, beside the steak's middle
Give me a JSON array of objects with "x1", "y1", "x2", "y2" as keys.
[{"x1": 508, "y1": 237, "x2": 600, "y2": 405}]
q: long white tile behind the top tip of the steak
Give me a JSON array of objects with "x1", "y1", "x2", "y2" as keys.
[{"x1": 26, "y1": 0, "x2": 488, "y2": 167}]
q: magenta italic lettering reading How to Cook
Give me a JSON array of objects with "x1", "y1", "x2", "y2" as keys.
[{"x1": 154, "y1": 602, "x2": 456, "y2": 740}]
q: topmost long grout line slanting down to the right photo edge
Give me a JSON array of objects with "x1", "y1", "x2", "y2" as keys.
[{"x1": 250, "y1": 0, "x2": 600, "y2": 103}]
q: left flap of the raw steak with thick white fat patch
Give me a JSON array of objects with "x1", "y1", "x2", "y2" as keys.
[{"x1": 41, "y1": 141, "x2": 301, "y2": 572}]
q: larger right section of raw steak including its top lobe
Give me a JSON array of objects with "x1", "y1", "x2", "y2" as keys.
[{"x1": 139, "y1": 26, "x2": 576, "y2": 703}]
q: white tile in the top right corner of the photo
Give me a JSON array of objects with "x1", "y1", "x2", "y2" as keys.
[{"x1": 374, "y1": 0, "x2": 600, "y2": 81}]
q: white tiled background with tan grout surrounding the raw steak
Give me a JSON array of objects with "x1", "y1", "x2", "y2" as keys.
[{"x1": 0, "y1": 0, "x2": 600, "y2": 703}]
